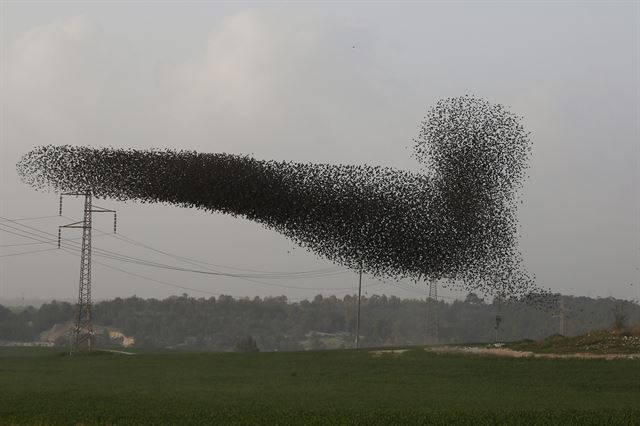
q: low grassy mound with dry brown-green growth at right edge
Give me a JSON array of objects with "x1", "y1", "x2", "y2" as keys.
[{"x1": 508, "y1": 327, "x2": 640, "y2": 354}]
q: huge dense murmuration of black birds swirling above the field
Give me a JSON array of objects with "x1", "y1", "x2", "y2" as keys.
[{"x1": 17, "y1": 96, "x2": 550, "y2": 304}]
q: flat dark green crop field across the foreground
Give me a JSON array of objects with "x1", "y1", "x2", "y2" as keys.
[{"x1": 0, "y1": 348, "x2": 640, "y2": 425}]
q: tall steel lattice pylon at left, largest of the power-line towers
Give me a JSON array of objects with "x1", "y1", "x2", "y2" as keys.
[{"x1": 58, "y1": 192, "x2": 116, "y2": 351}]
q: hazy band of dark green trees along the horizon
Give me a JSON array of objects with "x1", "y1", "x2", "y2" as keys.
[{"x1": 0, "y1": 293, "x2": 640, "y2": 351}]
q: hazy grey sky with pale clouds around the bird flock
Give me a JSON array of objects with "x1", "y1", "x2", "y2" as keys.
[{"x1": 0, "y1": 0, "x2": 640, "y2": 300}]
